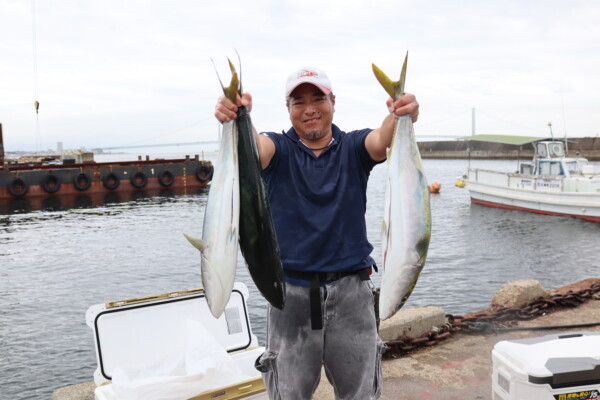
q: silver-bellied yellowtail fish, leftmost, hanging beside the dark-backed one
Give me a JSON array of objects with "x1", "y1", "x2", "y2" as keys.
[{"x1": 184, "y1": 62, "x2": 240, "y2": 318}]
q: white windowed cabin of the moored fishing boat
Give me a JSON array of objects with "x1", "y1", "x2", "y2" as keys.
[{"x1": 519, "y1": 140, "x2": 588, "y2": 177}]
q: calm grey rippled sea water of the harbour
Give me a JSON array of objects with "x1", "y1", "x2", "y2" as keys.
[{"x1": 0, "y1": 148, "x2": 600, "y2": 400}]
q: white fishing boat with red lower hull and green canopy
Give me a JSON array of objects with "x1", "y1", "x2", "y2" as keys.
[{"x1": 463, "y1": 135, "x2": 600, "y2": 222}]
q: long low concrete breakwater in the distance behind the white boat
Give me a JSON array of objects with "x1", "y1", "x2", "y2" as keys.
[{"x1": 418, "y1": 137, "x2": 600, "y2": 161}]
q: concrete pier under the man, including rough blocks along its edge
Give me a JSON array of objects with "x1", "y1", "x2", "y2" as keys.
[{"x1": 52, "y1": 278, "x2": 600, "y2": 400}]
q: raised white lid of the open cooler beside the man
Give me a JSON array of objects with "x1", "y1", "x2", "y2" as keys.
[{"x1": 86, "y1": 282, "x2": 256, "y2": 380}]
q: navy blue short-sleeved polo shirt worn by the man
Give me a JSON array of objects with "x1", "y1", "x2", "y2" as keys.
[{"x1": 263, "y1": 125, "x2": 378, "y2": 285}]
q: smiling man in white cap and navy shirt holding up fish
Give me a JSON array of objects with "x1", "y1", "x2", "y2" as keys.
[{"x1": 215, "y1": 67, "x2": 419, "y2": 400}]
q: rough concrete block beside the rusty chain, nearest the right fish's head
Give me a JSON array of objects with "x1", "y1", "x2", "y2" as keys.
[{"x1": 379, "y1": 306, "x2": 446, "y2": 342}]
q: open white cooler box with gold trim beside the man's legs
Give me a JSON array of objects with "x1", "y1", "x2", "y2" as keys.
[{"x1": 86, "y1": 282, "x2": 268, "y2": 400}]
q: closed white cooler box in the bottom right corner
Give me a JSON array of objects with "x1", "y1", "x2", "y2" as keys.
[{"x1": 492, "y1": 331, "x2": 600, "y2": 400}]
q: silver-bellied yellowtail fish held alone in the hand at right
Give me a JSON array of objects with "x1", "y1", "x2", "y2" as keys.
[{"x1": 373, "y1": 53, "x2": 431, "y2": 320}]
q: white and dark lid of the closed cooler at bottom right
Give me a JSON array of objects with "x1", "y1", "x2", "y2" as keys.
[{"x1": 494, "y1": 331, "x2": 600, "y2": 388}]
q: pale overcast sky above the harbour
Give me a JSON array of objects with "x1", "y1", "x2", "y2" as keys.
[{"x1": 0, "y1": 0, "x2": 600, "y2": 150}]
